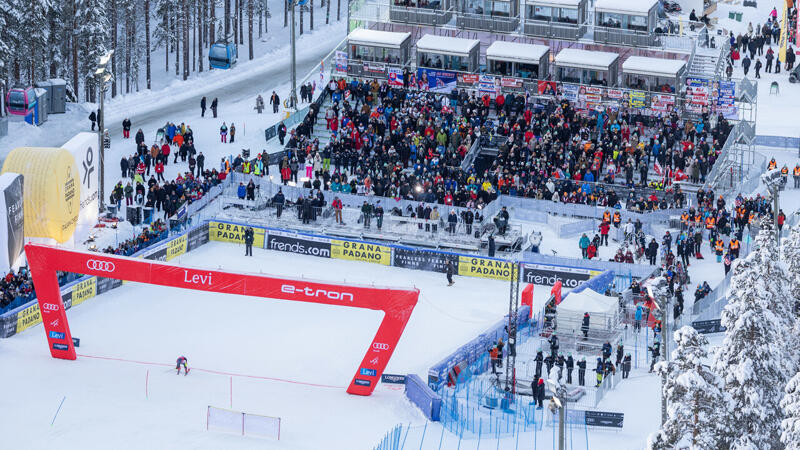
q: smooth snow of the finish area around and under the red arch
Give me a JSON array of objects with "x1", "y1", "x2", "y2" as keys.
[{"x1": 0, "y1": 242, "x2": 549, "y2": 450}]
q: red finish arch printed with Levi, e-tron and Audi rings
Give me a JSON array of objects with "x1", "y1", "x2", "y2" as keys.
[{"x1": 25, "y1": 244, "x2": 419, "y2": 395}]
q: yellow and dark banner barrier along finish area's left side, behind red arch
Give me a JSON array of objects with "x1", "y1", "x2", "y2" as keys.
[{"x1": 0, "y1": 224, "x2": 208, "y2": 338}]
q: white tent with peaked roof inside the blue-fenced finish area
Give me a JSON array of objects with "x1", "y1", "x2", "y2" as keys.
[{"x1": 556, "y1": 289, "x2": 619, "y2": 334}]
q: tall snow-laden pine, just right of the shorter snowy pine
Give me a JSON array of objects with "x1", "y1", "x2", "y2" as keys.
[{"x1": 714, "y1": 226, "x2": 794, "y2": 450}]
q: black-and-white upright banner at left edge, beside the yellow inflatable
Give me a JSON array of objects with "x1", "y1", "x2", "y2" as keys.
[{"x1": 0, "y1": 172, "x2": 25, "y2": 273}]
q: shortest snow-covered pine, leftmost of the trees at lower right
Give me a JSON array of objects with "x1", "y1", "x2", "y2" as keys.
[{"x1": 648, "y1": 326, "x2": 725, "y2": 450}]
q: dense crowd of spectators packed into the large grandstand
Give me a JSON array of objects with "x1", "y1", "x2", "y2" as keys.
[{"x1": 279, "y1": 80, "x2": 731, "y2": 211}]
